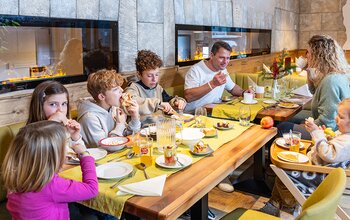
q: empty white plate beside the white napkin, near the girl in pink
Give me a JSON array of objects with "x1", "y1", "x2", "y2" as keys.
[{"x1": 96, "y1": 162, "x2": 133, "y2": 179}]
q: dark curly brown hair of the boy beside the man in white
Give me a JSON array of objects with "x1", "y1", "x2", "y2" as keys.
[{"x1": 135, "y1": 50, "x2": 163, "y2": 75}]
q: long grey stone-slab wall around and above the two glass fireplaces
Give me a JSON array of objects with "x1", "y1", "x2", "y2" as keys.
[{"x1": 0, "y1": 0, "x2": 299, "y2": 72}]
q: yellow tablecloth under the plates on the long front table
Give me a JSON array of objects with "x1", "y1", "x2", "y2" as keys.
[{"x1": 59, "y1": 118, "x2": 249, "y2": 218}]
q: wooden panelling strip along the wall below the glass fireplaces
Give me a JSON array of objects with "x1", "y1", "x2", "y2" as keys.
[{"x1": 0, "y1": 50, "x2": 350, "y2": 126}]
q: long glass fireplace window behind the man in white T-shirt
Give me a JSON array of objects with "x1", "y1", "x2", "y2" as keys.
[{"x1": 175, "y1": 25, "x2": 271, "y2": 66}]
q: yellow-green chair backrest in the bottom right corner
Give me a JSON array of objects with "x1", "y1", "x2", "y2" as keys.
[{"x1": 297, "y1": 168, "x2": 346, "y2": 220}]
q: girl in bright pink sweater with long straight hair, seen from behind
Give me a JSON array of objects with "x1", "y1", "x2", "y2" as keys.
[{"x1": 1, "y1": 121, "x2": 98, "y2": 219}]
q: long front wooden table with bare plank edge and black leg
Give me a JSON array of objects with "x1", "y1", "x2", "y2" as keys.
[{"x1": 124, "y1": 125, "x2": 277, "y2": 219}]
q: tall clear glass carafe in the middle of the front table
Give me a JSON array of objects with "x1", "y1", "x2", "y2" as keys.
[{"x1": 156, "y1": 116, "x2": 176, "y2": 153}]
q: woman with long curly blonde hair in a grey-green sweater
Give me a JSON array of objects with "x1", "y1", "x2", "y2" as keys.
[{"x1": 278, "y1": 35, "x2": 350, "y2": 139}]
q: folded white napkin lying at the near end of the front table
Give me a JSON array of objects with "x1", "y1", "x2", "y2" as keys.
[{"x1": 117, "y1": 175, "x2": 166, "y2": 196}]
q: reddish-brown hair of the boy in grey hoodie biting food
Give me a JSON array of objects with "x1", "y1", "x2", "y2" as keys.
[{"x1": 87, "y1": 69, "x2": 124, "y2": 101}]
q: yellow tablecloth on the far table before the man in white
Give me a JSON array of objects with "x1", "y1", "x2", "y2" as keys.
[{"x1": 211, "y1": 99, "x2": 268, "y2": 121}]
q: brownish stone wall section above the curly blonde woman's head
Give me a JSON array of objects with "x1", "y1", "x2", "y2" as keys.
[{"x1": 298, "y1": 0, "x2": 349, "y2": 49}]
